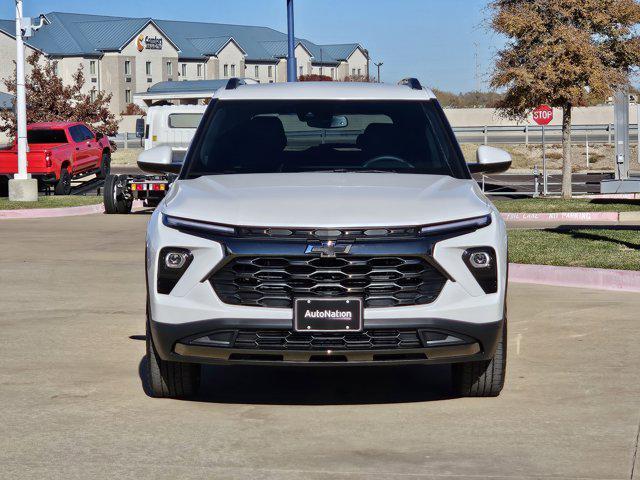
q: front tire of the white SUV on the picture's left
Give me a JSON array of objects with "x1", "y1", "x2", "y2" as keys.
[{"x1": 147, "y1": 305, "x2": 200, "y2": 398}]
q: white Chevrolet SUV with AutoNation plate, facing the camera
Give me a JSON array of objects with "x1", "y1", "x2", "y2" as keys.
[{"x1": 144, "y1": 79, "x2": 511, "y2": 397}]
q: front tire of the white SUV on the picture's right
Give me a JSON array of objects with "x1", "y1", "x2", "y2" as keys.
[{"x1": 452, "y1": 320, "x2": 507, "y2": 397}]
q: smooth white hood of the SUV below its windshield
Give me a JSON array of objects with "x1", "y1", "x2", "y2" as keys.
[{"x1": 163, "y1": 172, "x2": 491, "y2": 228}]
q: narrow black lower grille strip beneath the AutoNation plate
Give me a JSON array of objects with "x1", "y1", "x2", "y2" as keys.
[{"x1": 234, "y1": 330, "x2": 422, "y2": 351}]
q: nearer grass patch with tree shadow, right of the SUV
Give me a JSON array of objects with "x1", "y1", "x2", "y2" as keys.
[{"x1": 509, "y1": 228, "x2": 640, "y2": 270}]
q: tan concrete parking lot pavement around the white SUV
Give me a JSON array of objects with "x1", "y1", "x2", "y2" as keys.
[{"x1": 0, "y1": 214, "x2": 640, "y2": 480}]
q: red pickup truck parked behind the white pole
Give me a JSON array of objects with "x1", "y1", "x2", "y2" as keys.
[{"x1": 0, "y1": 122, "x2": 111, "y2": 195}]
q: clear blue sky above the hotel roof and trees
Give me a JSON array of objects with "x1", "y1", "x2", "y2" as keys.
[{"x1": 0, "y1": 0, "x2": 501, "y2": 92}]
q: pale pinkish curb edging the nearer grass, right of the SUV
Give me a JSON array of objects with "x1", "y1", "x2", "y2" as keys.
[{"x1": 509, "y1": 263, "x2": 640, "y2": 292}]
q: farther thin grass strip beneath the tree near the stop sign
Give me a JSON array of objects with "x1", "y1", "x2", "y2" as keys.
[{"x1": 493, "y1": 198, "x2": 640, "y2": 213}]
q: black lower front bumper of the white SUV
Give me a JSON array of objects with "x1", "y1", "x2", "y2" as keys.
[{"x1": 150, "y1": 318, "x2": 504, "y2": 366}]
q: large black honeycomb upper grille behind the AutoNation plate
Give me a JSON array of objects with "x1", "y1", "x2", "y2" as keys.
[{"x1": 210, "y1": 256, "x2": 447, "y2": 308}]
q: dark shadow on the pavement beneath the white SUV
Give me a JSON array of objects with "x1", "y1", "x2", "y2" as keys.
[{"x1": 138, "y1": 357, "x2": 455, "y2": 405}]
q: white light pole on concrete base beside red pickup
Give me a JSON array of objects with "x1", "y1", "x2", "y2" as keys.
[{"x1": 9, "y1": 0, "x2": 44, "y2": 202}]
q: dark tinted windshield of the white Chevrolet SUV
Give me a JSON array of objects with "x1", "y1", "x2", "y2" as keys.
[{"x1": 181, "y1": 100, "x2": 469, "y2": 178}]
